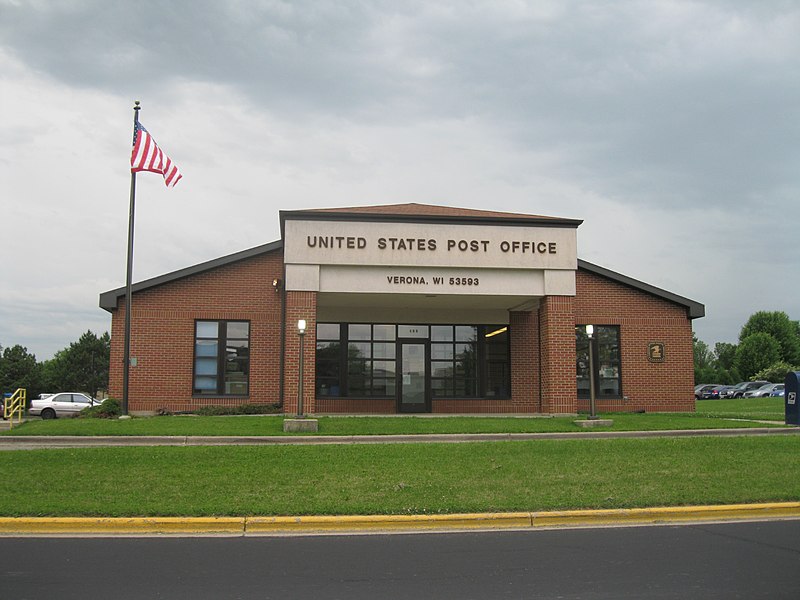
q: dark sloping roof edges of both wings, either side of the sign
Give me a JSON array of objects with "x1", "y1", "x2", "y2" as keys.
[{"x1": 100, "y1": 240, "x2": 705, "y2": 319}]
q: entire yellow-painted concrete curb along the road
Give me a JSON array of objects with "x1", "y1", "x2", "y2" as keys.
[{"x1": 0, "y1": 502, "x2": 800, "y2": 537}]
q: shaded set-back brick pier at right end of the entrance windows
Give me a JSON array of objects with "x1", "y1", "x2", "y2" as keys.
[{"x1": 508, "y1": 311, "x2": 542, "y2": 413}]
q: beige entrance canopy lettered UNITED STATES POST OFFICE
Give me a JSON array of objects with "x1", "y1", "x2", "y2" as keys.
[{"x1": 281, "y1": 205, "x2": 580, "y2": 312}]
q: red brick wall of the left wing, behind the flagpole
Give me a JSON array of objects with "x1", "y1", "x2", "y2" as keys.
[{"x1": 109, "y1": 250, "x2": 284, "y2": 411}]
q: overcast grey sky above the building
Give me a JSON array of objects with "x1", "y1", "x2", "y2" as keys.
[{"x1": 0, "y1": 0, "x2": 800, "y2": 360}]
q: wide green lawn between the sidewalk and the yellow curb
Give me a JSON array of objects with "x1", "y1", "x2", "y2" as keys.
[{"x1": 0, "y1": 436, "x2": 800, "y2": 516}]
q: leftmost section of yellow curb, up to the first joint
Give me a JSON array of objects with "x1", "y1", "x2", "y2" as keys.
[{"x1": 0, "y1": 517, "x2": 244, "y2": 535}]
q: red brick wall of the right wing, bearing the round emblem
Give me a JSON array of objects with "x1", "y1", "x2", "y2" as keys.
[{"x1": 573, "y1": 270, "x2": 694, "y2": 411}]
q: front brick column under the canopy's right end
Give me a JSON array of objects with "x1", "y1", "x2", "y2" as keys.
[{"x1": 539, "y1": 296, "x2": 578, "y2": 414}]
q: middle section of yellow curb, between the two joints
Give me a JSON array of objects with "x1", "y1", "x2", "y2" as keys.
[{"x1": 245, "y1": 512, "x2": 531, "y2": 533}]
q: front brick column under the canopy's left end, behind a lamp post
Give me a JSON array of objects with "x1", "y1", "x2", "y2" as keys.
[{"x1": 282, "y1": 291, "x2": 317, "y2": 415}]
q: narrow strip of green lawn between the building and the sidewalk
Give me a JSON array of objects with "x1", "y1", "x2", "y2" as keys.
[{"x1": 0, "y1": 398, "x2": 783, "y2": 436}]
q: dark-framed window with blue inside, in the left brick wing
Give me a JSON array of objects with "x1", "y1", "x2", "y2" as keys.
[{"x1": 193, "y1": 321, "x2": 250, "y2": 396}]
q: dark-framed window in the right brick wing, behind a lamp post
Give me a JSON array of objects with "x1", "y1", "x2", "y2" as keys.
[{"x1": 575, "y1": 325, "x2": 622, "y2": 398}]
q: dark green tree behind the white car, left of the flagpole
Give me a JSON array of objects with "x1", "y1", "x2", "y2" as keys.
[{"x1": 43, "y1": 331, "x2": 111, "y2": 397}]
